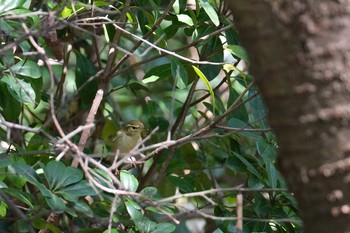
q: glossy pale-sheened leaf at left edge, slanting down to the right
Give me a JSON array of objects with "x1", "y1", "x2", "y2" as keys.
[{"x1": 1, "y1": 75, "x2": 35, "y2": 105}]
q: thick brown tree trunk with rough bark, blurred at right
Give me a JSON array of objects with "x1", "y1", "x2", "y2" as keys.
[{"x1": 228, "y1": 0, "x2": 350, "y2": 233}]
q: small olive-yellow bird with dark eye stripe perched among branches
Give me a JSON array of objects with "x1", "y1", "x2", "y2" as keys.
[{"x1": 109, "y1": 120, "x2": 145, "y2": 160}]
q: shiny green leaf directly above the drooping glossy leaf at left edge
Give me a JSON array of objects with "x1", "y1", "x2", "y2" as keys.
[{"x1": 10, "y1": 60, "x2": 41, "y2": 78}]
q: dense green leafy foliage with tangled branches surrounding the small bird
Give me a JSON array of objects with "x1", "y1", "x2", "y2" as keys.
[{"x1": 0, "y1": 0, "x2": 300, "y2": 232}]
